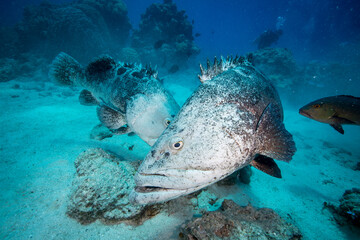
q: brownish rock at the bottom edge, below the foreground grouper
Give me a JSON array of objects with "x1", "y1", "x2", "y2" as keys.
[{"x1": 179, "y1": 200, "x2": 302, "y2": 240}]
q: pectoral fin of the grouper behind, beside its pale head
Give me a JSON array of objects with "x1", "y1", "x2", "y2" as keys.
[{"x1": 96, "y1": 105, "x2": 126, "y2": 129}]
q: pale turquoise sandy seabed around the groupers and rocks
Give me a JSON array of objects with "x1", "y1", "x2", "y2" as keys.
[{"x1": 0, "y1": 72, "x2": 360, "y2": 240}]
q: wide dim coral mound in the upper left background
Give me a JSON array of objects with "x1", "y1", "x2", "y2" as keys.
[{"x1": 14, "y1": 0, "x2": 131, "y2": 61}]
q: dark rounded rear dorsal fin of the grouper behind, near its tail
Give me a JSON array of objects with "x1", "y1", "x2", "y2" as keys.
[{"x1": 85, "y1": 55, "x2": 116, "y2": 82}]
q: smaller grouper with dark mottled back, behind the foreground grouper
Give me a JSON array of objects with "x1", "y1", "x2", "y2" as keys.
[{"x1": 49, "y1": 53, "x2": 179, "y2": 145}]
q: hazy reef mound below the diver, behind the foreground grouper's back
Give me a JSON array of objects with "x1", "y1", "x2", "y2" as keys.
[{"x1": 252, "y1": 48, "x2": 301, "y2": 89}]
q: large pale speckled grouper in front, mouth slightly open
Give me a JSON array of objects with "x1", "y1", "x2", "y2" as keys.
[{"x1": 130, "y1": 57, "x2": 296, "y2": 204}]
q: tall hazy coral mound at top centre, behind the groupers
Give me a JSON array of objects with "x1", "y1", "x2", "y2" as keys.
[{"x1": 131, "y1": 0, "x2": 200, "y2": 70}]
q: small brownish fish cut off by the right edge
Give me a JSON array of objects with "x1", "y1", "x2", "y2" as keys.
[{"x1": 299, "y1": 95, "x2": 360, "y2": 134}]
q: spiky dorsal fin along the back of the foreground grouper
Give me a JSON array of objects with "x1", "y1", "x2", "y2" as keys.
[{"x1": 198, "y1": 54, "x2": 252, "y2": 83}]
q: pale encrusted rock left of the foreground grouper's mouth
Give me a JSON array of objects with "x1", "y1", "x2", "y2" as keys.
[{"x1": 67, "y1": 149, "x2": 146, "y2": 224}]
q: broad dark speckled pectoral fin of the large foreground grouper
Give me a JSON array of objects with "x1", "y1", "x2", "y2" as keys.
[{"x1": 256, "y1": 103, "x2": 296, "y2": 162}]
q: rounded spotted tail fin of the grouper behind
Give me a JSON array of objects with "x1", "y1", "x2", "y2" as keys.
[{"x1": 49, "y1": 52, "x2": 84, "y2": 86}]
